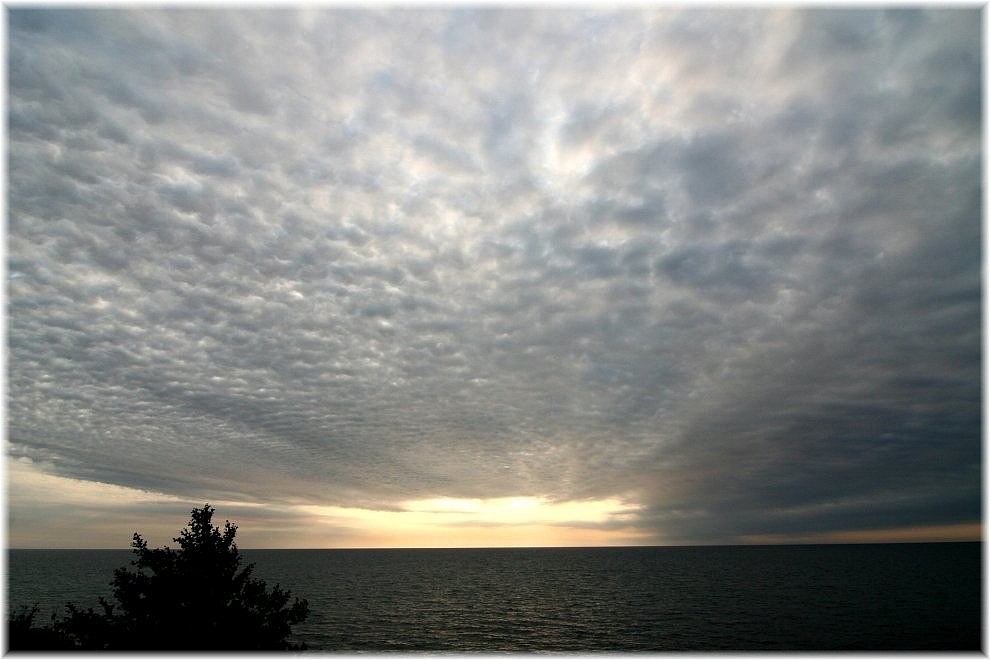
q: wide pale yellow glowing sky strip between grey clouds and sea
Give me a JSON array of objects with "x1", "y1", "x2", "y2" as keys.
[{"x1": 4, "y1": 458, "x2": 651, "y2": 548}]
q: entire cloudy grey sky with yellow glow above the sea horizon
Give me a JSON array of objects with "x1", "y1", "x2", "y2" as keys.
[{"x1": 5, "y1": 6, "x2": 983, "y2": 548}]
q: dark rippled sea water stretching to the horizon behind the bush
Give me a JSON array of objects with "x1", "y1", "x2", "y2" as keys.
[{"x1": 7, "y1": 543, "x2": 982, "y2": 652}]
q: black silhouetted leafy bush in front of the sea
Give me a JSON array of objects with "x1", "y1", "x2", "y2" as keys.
[{"x1": 8, "y1": 504, "x2": 309, "y2": 651}]
